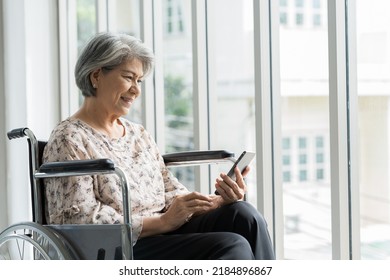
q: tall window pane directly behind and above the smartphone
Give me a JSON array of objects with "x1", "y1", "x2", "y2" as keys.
[{"x1": 207, "y1": 0, "x2": 256, "y2": 203}]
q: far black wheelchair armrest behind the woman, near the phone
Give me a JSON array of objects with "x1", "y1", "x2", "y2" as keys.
[{"x1": 163, "y1": 150, "x2": 234, "y2": 166}]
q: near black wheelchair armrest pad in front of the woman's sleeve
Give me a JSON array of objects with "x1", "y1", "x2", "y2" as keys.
[{"x1": 35, "y1": 159, "x2": 115, "y2": 178}]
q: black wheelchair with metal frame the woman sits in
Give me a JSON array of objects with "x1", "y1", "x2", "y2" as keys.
[{"x1": 0, "y1": 127, "x2": 235, "y2": 260}]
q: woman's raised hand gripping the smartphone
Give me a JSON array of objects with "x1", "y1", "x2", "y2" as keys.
[{"x1": 215, "y1": 167, "x2": 250, "y2": 203}]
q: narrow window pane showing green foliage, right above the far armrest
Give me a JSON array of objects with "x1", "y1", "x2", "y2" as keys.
[{"x1": 162, "y1": 0, "x2": 194, "y2": 189}]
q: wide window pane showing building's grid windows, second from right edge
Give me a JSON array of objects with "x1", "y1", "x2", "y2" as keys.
[{"x1": 280, "y1": 0, "x2": 332, "y2": 259}]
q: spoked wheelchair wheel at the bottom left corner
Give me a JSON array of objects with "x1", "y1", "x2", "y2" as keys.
[{"x1": 0, "y1": 222, "x2": 74, "y2": 260}]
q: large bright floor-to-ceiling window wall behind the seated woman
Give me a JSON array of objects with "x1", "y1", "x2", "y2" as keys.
[{"x1": 60, "y1": 0, "x2": 390, "y2": 259}]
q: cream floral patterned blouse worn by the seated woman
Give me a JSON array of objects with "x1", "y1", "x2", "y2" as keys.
[{"x1": 43, "y1": 118, "x2": 188, "y2": 244}]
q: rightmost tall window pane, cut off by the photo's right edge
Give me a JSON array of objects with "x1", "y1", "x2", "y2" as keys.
[{"x1": 356, "y1": 0, "x2": 390, "y2": 259}]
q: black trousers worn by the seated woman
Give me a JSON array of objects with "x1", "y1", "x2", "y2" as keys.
[{"x1": 134, "y1": 201, "x2": 275, "y2": 260}]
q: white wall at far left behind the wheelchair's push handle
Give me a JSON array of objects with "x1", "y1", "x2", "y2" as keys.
[{"x1": 0, "y1": 0, "x2": 60, "y2": 230}]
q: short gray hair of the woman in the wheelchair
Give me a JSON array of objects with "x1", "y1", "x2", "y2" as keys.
[{"x1": 74, "y1": 32, "x2": 154, "y2": 97}]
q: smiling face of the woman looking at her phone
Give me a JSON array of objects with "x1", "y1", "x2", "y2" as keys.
[{"x1": 91, "y1": 59, "x2": 143, "y2": 118}]
